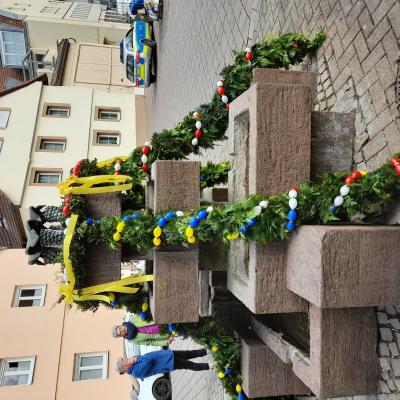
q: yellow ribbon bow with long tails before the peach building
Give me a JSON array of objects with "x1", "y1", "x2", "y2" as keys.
[{"x1": 59, "y1": 214, "x2": 153, "y2": 304}]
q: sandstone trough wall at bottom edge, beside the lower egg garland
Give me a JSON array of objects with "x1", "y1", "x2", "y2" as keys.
[{"x1": 236, "y1": 329, "x2": 310, "y2": 398}]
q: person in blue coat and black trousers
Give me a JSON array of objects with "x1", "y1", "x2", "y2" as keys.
[{"x1": 115, "y1": 349, "x2": 210, "y2": 379}]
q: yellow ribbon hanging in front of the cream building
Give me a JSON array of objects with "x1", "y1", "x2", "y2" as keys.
[{"x1": 57, "y1": 175, "x2": 132, "y2": 195}]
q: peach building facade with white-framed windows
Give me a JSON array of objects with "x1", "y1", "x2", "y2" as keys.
[{"x1": 0, "y1": 249, "x2": 130, "y2": 400}]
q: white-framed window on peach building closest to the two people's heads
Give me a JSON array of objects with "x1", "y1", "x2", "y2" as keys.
[{"x1": 74, "y1": 352, "x2": 108, "y2": 381}]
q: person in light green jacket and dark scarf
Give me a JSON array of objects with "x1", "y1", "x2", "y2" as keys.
[{"x1": 112, "y1": 314, "x2": 174, "y2": 346}]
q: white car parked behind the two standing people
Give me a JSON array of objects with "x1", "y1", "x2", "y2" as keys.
[{"x1": 124, "y1": 313, "x2": 172, "y2": 400}]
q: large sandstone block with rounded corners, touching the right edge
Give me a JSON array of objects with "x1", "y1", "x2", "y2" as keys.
[{"x1": 287, "y1": 225, "x2": 400, "y2": 308}]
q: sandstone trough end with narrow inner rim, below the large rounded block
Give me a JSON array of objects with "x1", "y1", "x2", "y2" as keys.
[{"x1": 250, "y1": 305, "x2": 379, "y2": 398}]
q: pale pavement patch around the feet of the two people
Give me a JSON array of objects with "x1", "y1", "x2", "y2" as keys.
[{"x1": 170, "y1": 339, "x2": 230, "y2": 400}]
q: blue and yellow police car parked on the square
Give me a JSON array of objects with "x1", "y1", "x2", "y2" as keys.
[{"x1": 120, "y1": 21, "x2": 156, "y2": 88}]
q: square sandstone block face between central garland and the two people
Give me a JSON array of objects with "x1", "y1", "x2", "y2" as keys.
[{"x1": 150, "y1": 250, "x2": 199, "y2": 324}]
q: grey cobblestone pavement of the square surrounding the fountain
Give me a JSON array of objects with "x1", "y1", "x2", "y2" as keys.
[{"x1": 147, "y1": 0, "x2": 400, "y2": 400}]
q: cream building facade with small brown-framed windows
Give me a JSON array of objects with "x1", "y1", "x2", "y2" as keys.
[{"x1": 0, "y1": 75, "x2": 136, "y2": 209}]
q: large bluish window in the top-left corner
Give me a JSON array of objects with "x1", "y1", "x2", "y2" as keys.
[{"x1": 0, "y1": 31, "x2": 26, "y2": 67}]
